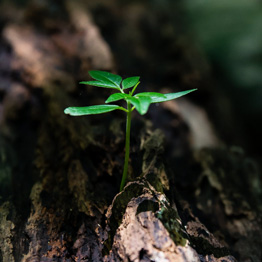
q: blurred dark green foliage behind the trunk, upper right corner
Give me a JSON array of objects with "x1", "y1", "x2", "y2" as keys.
[{"x1": 185, "y1": 0, "x2": 262, "y2": 114}]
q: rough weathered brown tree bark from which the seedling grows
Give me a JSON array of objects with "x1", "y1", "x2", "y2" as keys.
[{"x1": 0, "y1": 1, "x2": 262, "y2": 262}]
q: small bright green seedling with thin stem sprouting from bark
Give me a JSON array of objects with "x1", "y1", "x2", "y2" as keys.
[{"x1": 64, "y1": 71, "x2": 196, "y2": 191}]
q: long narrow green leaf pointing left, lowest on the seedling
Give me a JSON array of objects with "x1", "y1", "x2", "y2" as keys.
[{"x1": 64, "y1": 105, "x2": 124, "y2": 116}]
